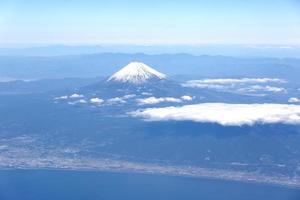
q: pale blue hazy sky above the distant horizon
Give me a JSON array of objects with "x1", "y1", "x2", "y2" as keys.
[{"x1": 0, "y1": 0, "x2": 300, "y2": 45}]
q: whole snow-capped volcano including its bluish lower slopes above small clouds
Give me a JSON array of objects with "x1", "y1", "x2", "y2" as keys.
[{"x1": 83, "y1": 62, "x2": 183, "y2": 96}]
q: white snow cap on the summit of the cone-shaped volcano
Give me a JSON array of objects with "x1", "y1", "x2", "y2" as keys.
[{"x1": 107, "y1": 62, "x2": 166, "y2": 84}]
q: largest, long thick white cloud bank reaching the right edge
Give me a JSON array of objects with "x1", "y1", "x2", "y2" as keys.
[{"x1": 129, "y1": 103, "x2": 300, "y2": 126}]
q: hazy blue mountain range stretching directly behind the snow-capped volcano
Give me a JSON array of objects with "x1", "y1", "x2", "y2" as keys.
[{"x1": 0, "y1": 53, "x2": 300, "y2": 81}]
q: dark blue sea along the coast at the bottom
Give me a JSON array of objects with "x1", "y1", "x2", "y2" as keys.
[{"x1": 0, "y1": 170, "x2": 300, "y2": 200}]
